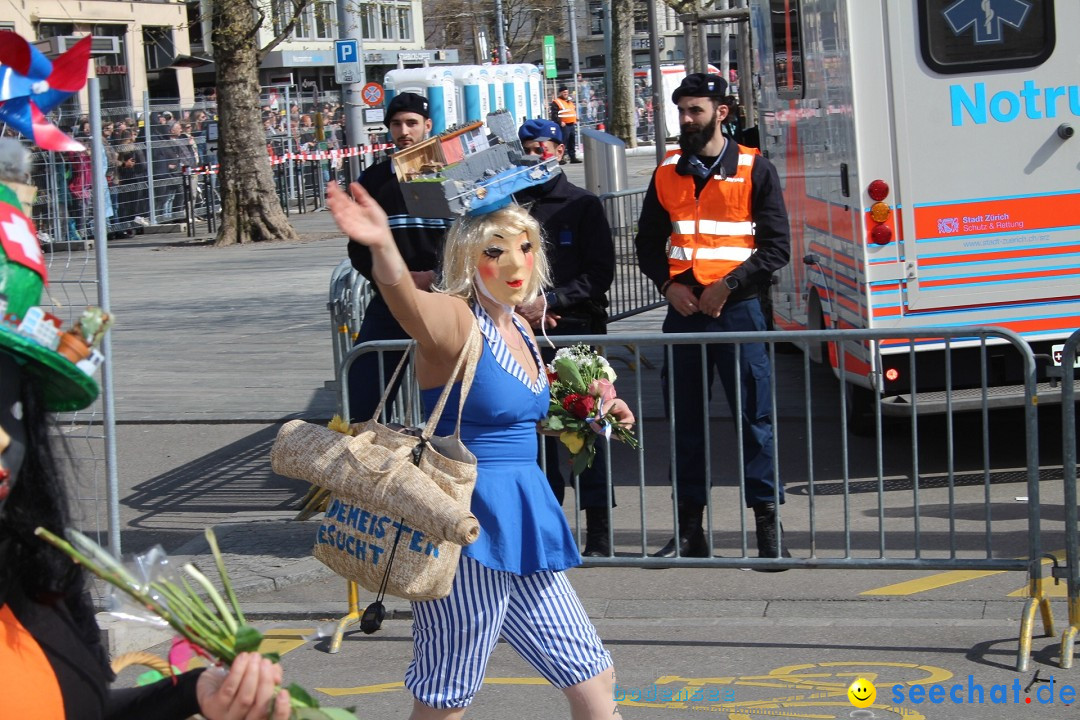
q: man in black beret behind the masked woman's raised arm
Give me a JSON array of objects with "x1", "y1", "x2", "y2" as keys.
[{"x1": 349, "y1": 93, "x2": 451, "y2": 421}]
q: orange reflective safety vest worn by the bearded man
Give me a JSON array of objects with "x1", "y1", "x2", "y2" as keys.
[{"x1": 656, "y1": 145, "x2": 760, "y2": 285}]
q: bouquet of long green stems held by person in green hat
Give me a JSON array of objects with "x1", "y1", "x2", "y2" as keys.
[{"x1": 35, "y1": 528, "x2": 356, "y2": 720}]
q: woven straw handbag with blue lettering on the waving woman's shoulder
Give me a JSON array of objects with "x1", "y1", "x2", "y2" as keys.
[{"x1": 270, "y1": 325, "x2": 484, "y2": 602}]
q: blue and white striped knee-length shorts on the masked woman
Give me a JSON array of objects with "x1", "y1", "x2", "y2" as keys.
[{"x1": 405, "y1": 555, "x2": 611, "y2": 709}]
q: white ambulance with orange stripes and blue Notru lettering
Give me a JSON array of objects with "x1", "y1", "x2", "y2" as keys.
[{"x1": 750, "y1": 0, "x2": 1080, "y2": 415}]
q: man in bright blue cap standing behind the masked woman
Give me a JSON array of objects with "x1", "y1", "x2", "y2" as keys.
[{"x1": 514, "y1": 118, "x2": 615, "y2": 557}]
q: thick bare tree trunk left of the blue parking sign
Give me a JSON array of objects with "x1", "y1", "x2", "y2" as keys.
[{"x1": 213, "y1": 0, "x2": 297, "y2": 247}]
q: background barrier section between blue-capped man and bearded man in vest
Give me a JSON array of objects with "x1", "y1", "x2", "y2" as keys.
[{"x1": 600, "y1": 188, "x2": 664, "y2": 323}]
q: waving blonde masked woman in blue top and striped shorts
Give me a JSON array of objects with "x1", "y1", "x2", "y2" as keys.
[{"x1": 327, "y1": 182, "x2": 634, "y2": 720}]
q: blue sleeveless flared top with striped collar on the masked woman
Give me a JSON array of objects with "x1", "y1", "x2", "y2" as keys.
[{"x1": 421, "y1": 303, "x2": 581, "y2": 575}]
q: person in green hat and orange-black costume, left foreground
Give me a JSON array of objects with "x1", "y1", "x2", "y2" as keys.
[{"x1": 0, "y1": 141, "x2": 289, "y2": 720}]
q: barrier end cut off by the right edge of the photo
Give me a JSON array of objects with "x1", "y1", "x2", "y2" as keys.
[{"x1": 1055, "y1": 330, "x2": 1080, "y2": 668}]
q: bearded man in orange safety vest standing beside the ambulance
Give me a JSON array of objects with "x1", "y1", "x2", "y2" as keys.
[{"x1": 635, "y1": 72, "x2": 791, "y2": 569}]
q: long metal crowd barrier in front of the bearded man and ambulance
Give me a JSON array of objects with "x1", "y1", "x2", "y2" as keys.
[{"x1": 338, "y1": 327, "x2": 1054, "y2": 670}]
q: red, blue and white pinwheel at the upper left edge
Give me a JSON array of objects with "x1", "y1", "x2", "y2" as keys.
[{"x1": 0, "y1": 30, "x2": 91, "y2": 152}]
